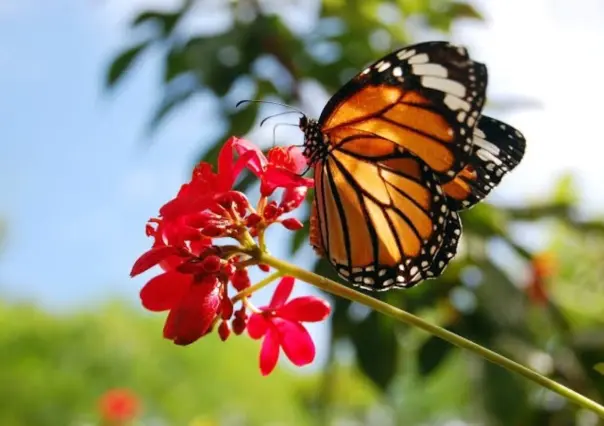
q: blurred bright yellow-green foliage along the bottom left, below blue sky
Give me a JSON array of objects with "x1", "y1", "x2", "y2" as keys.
[{"x1": 0, "y1": 302, "x2": 382, "y2": 426}]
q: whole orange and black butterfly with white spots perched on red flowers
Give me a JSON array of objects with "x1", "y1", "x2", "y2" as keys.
[{"x1": 299, "y1": 42, "x2": 525, "y2": 291}]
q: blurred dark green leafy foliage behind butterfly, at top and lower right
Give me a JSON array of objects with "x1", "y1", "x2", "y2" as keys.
[{"x1": 106, "y1": 0, "x2": 604, "y2": 426}]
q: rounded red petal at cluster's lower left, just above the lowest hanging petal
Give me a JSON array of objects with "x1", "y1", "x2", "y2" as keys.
[{"x1": 140, "y1": 271, "x2": 193, "y2": 312}]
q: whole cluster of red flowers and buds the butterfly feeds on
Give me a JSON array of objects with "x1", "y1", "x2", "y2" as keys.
[{"x1": 131, "y1": 137, "x2": 329, "y2": 374}]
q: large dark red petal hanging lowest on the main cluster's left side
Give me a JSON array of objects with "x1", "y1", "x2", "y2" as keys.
[{"x1": 164, "y1": 280, "x2": 221, "y2": 345}]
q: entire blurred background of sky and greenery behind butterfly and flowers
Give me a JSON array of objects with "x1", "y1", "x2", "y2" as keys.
[{"x1": 0, "y1": 0, "x2": 604, "y2": 426}]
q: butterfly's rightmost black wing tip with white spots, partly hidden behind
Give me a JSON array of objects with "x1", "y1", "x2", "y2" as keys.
[{"x1": 443, "y1": 115, "x2": 526, "y2": 210}]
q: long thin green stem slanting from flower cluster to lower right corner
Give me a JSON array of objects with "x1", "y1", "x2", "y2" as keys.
[{"x1": 258, "y1": 253, "x2": 604, "y2": 418}]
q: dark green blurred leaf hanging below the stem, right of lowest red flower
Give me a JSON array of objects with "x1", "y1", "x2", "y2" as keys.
[{"x1": 351, "y1": 312, "x2": 399, "y2": 391}]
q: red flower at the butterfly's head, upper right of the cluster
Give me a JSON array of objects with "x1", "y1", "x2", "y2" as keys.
[{"x1": 233, "y1": 139, "x2": 313, "y2": 197}]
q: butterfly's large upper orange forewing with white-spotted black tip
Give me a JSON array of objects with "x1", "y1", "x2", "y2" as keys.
[{"x1": 319, "y1": 42, "x2": 487, "y2": 181}]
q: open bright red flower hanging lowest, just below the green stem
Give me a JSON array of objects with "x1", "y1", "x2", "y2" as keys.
[{"x1": 247, "y1": 277, "x2": 330, "y2": 376}]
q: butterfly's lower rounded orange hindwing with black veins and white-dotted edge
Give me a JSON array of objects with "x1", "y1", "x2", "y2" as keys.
[{"x1": 310, "y1": 140, "x2": 456, "y2": 291}]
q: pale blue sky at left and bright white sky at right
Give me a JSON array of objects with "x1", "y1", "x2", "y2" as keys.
[{"x1": 0, "y1": 0, "x2": 604, "y2": 307}]
